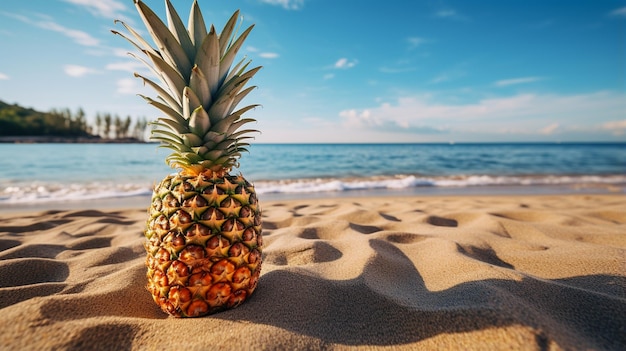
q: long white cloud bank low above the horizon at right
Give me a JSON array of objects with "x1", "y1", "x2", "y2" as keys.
[{"x1": 339, "y1": 92, "x2": 626, "y2": 135}]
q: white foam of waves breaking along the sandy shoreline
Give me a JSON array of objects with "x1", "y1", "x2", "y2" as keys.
[{"x1": 0, "y1": 175, "x2": 626, "y2": 204}]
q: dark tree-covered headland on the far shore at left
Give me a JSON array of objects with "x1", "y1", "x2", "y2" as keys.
[{"x1": 0, "y1": 101, "x2": 148, "y2": 140}]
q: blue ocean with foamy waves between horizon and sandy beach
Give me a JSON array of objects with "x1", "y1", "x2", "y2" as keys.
[{"x1": 0, "y1": 143, "x2": 626, "y2": 209}]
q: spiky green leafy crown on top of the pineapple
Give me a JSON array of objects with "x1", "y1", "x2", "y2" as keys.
[{"x1": 112, "y1": 0, "x2": 261, "y2": 174}]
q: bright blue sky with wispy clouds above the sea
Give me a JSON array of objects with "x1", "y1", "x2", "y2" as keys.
[{"x1": 0, "y1": 0, "x2": 626, "y2": 143}]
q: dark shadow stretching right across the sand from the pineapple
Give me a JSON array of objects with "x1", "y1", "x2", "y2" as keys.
[{"x1": 219, "y1": 239, "x2": 626, "y2": 349}]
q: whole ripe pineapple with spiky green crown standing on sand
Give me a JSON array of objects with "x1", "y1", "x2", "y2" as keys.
[{"x1": 112, "y1": 0, "x2": 263, "y2": 317}]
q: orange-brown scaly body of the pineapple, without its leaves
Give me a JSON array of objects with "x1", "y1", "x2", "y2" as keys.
[{"x1": 145, "y1": 171, "x2": 263, "y2": 317}]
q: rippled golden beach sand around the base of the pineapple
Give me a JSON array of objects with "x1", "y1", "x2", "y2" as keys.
[{"x1": 0, "y1": 195, "x2": 626, "y2": 350}]
